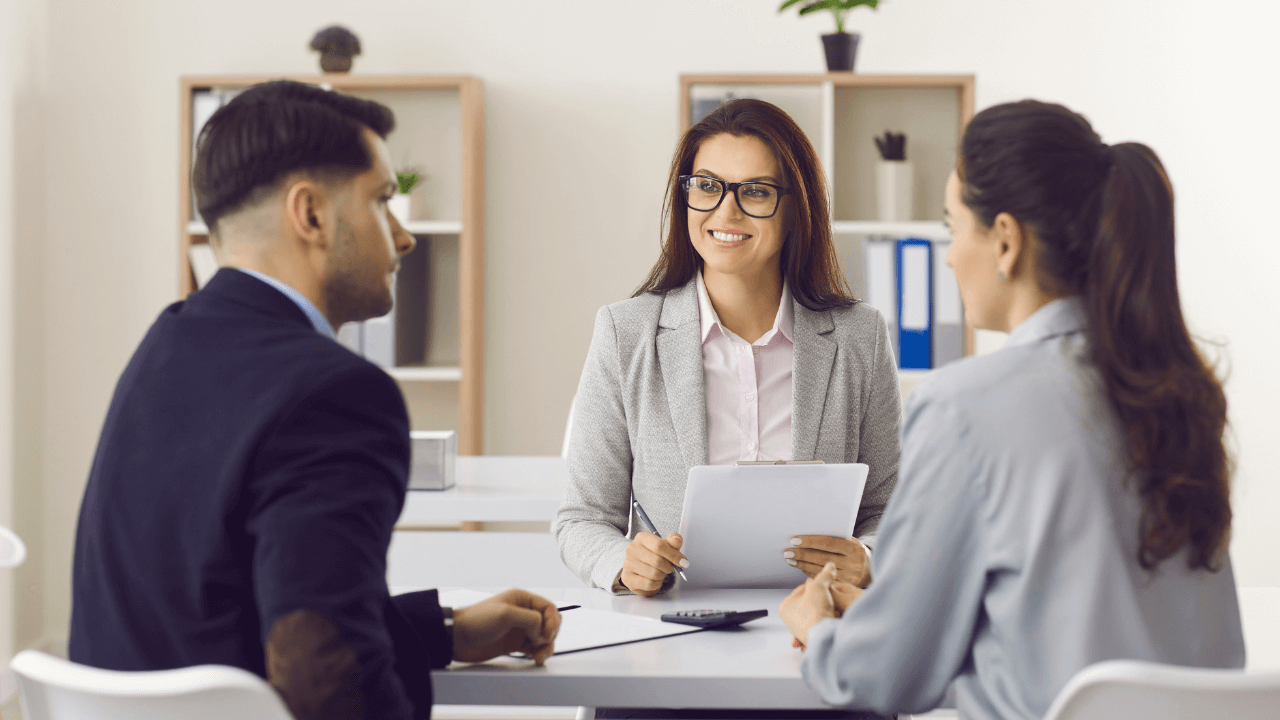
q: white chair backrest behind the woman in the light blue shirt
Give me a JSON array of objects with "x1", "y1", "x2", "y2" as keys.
[{"x1": 1044, "y1": 660, "x2": 1280, "y2": 720}]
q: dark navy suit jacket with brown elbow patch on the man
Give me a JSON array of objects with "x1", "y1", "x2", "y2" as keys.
[{"x1": 70, "y1": 269, "x2": 452, "y2": 719}]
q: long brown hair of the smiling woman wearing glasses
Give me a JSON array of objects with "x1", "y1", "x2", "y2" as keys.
[{"x1": 632, "y1": 99, "x2": 855, "y2": 310}]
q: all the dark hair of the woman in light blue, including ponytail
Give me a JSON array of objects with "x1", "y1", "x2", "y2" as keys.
[{"x1": 956, "y1": 100, "x2": 1231, "y2": 570}]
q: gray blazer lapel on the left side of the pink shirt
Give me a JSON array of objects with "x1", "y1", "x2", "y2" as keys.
[{"x1": 658, "y1": 282, "x2": 708, "y2": 468}]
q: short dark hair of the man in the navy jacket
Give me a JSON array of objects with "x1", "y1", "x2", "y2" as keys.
[{"x1": 191, "y1": 79, "x2": 396, "y2": 232}]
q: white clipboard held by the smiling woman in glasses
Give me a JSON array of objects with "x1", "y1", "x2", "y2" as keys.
[{"x1": 677, "y1": 462, "x2": 868, "y2": 588}]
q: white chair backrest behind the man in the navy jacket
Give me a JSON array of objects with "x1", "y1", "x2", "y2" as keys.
[{"x1": 10, "y1": 650, "x2": 292, "y2": 720}]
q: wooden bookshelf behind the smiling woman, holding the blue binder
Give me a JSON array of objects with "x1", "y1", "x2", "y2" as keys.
[{"x1": 678, "y1": 73, "x2": 974, "y2": 358}]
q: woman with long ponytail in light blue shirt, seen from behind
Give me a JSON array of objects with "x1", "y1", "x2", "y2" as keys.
[{"x1": 781, "y1": 100, "x2": 1244, "y2": 719}]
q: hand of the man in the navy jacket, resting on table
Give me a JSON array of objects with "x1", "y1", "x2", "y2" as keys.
[{"x1": 453, "y1": 589, "x2": 559, "y2": 665}]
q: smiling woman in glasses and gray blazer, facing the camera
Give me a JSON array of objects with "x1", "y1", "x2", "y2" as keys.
[{"x1": 553, "y1": 100, "x2": 901, "y2": 596}]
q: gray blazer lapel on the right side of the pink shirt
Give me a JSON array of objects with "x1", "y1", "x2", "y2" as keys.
[{"x1": 791, "y1": 302, "x2": 836, "y2": 460}]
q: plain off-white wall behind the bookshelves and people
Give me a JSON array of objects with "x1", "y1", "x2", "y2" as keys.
[{"x1": 0, "y1": 0, "x2": 1280, "y2": 648}]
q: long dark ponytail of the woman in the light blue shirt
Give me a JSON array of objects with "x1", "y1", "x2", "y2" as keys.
[{"x1": 1084, "y1": 142, "x2": 1231, "y2": 569}]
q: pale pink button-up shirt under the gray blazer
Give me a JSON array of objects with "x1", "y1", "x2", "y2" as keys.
[{"x1": 698, "y1": 273, "x2": 795, "y2": 465}]
